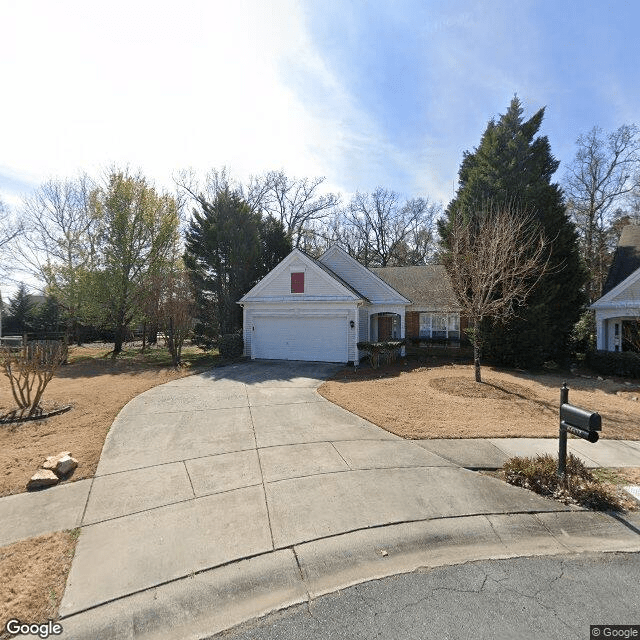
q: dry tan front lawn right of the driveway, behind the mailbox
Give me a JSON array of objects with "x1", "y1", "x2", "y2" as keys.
[{"x1": 318, "y1": 362, "x2": 640, "y2": 440}]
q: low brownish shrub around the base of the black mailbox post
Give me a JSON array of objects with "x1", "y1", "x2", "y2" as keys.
[{"x1": 503, "y1": 454, "x2": 623, "y2": 511}]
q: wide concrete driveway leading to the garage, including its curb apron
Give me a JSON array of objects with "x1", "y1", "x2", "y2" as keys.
[{"x1": 60, "y1": 361, "x2": 637, "y2": 638}]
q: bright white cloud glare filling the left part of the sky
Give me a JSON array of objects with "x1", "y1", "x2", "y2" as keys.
[{"x1": 0, "y1": 0, "x2": 444, "y2": 206}]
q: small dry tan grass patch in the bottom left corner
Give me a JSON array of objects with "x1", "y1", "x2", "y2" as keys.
[{"x1": 0, "y1": 531, "x2": 78, "y2": 638}]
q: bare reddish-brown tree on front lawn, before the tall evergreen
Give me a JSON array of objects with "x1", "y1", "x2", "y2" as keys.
[{"x1": 443, "y1": 204, "x2": 549, "y2": 382}]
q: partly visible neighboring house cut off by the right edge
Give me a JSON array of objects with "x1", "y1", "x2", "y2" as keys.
[{"x1": 590, "y1": 225, "x2": 640, "y2": 351}]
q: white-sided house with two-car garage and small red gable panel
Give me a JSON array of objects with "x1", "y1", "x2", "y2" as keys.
[{"x1": 239, "y1": 245, "x2": 461, "y2": 364}]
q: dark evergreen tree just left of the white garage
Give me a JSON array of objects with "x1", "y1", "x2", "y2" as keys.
[{"x1": 184, "y1": 187, "x2": 291, "y2": 347}]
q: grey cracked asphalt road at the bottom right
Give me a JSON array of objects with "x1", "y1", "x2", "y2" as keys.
[{"x1": 212, "y1": 553, "x2": 640, "y2": 640}]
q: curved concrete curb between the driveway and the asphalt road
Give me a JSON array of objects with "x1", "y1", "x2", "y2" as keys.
[{"x1": 60, "y1": 511, "x2": 640, "y2": 640}]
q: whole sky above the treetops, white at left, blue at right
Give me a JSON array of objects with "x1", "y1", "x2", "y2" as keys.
[{"x1": 0, "y1": 0, "x2": 640, "y2": 218}]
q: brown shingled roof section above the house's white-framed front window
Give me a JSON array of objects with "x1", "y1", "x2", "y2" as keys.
[{"x1": 371, "y1": 264, "x2": 460, "y2": 309}]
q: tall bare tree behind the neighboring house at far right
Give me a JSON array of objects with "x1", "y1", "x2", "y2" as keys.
[{"x1": 565, "y1": 124, "x2": 640, "y2": 302}]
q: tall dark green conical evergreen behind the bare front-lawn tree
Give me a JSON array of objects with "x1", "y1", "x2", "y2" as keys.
[{"x1": 439, "y1": 97, "x2": 585, "y2": 367}]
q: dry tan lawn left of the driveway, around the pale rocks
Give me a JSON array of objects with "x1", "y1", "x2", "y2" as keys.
[{"x1": 0, "y1": 347, "x2": 195, "y2": 496}]
